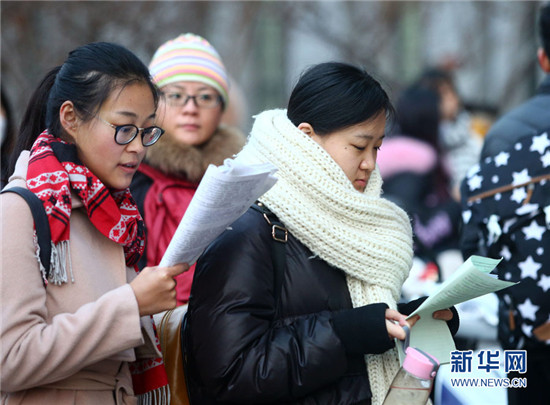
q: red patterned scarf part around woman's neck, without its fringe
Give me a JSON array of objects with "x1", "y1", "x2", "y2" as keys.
[{"x1": 27, "y1": 131, "x2": 145, "y2": 274}]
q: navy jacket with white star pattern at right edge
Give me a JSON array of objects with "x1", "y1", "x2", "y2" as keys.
[{"x1": 461, "y1": 130, "x2": 550, "y2": 349}]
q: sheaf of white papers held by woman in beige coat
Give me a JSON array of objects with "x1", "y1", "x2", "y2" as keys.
[{"x1": 159, "y1": 159, "x2": 277, "y2": 266}]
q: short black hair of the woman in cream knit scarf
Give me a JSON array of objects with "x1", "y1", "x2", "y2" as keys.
[{"x1": 287, "y1": 62, "x2": 394, "y2": 135}]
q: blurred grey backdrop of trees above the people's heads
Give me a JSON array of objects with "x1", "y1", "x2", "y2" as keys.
[{"x1": 0, "y1": 0, "x2": 542, "y2": 131}]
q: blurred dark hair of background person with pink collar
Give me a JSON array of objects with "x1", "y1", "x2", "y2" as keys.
[{"x1": 396, "y1": 84, "x2": 440, "y2": 149}]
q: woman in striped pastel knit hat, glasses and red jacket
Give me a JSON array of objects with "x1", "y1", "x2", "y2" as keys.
[{"x1": 131, "y1": 33, "x2": 246, "y2": 304}]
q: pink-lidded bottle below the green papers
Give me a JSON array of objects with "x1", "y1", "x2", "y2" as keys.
[{"x1": 383, "y1": 346, "x2": 439, "y2": 405}]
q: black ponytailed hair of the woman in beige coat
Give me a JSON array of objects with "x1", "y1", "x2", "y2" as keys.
[{"x1": 10, "y1": 42, "x2": 158, "y2": 176}]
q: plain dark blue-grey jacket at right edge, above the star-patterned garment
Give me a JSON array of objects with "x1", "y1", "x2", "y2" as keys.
[{"x1": 481, "y1": 74, "x2": 550, "y2": 161}]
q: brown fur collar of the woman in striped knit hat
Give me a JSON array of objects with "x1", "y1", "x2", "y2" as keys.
[{"x1": 145, "y1": 125, "x2": 246, "y2": 183}]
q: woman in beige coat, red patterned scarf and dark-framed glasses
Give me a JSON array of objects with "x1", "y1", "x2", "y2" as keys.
[{"x1": 0, "y1": 42, "x2": 189, "y2": 404}]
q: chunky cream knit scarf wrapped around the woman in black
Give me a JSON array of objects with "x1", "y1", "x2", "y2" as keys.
[{"x1": 237, "y1": 110, "x2": 413, "y2": 405}]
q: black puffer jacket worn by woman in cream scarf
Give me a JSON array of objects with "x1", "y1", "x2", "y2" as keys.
[{"x1": 185, "y1": 209, "x2": 458, "y2": 405}]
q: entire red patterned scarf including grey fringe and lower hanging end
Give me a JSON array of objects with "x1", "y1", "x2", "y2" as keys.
[{"x1": 27, "y1": 131, "x2": 170, "y2": 404}]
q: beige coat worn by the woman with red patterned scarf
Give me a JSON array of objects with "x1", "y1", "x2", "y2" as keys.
[{"x1": 0, "y1": 152, "x2": 160, "y2": 405}]
